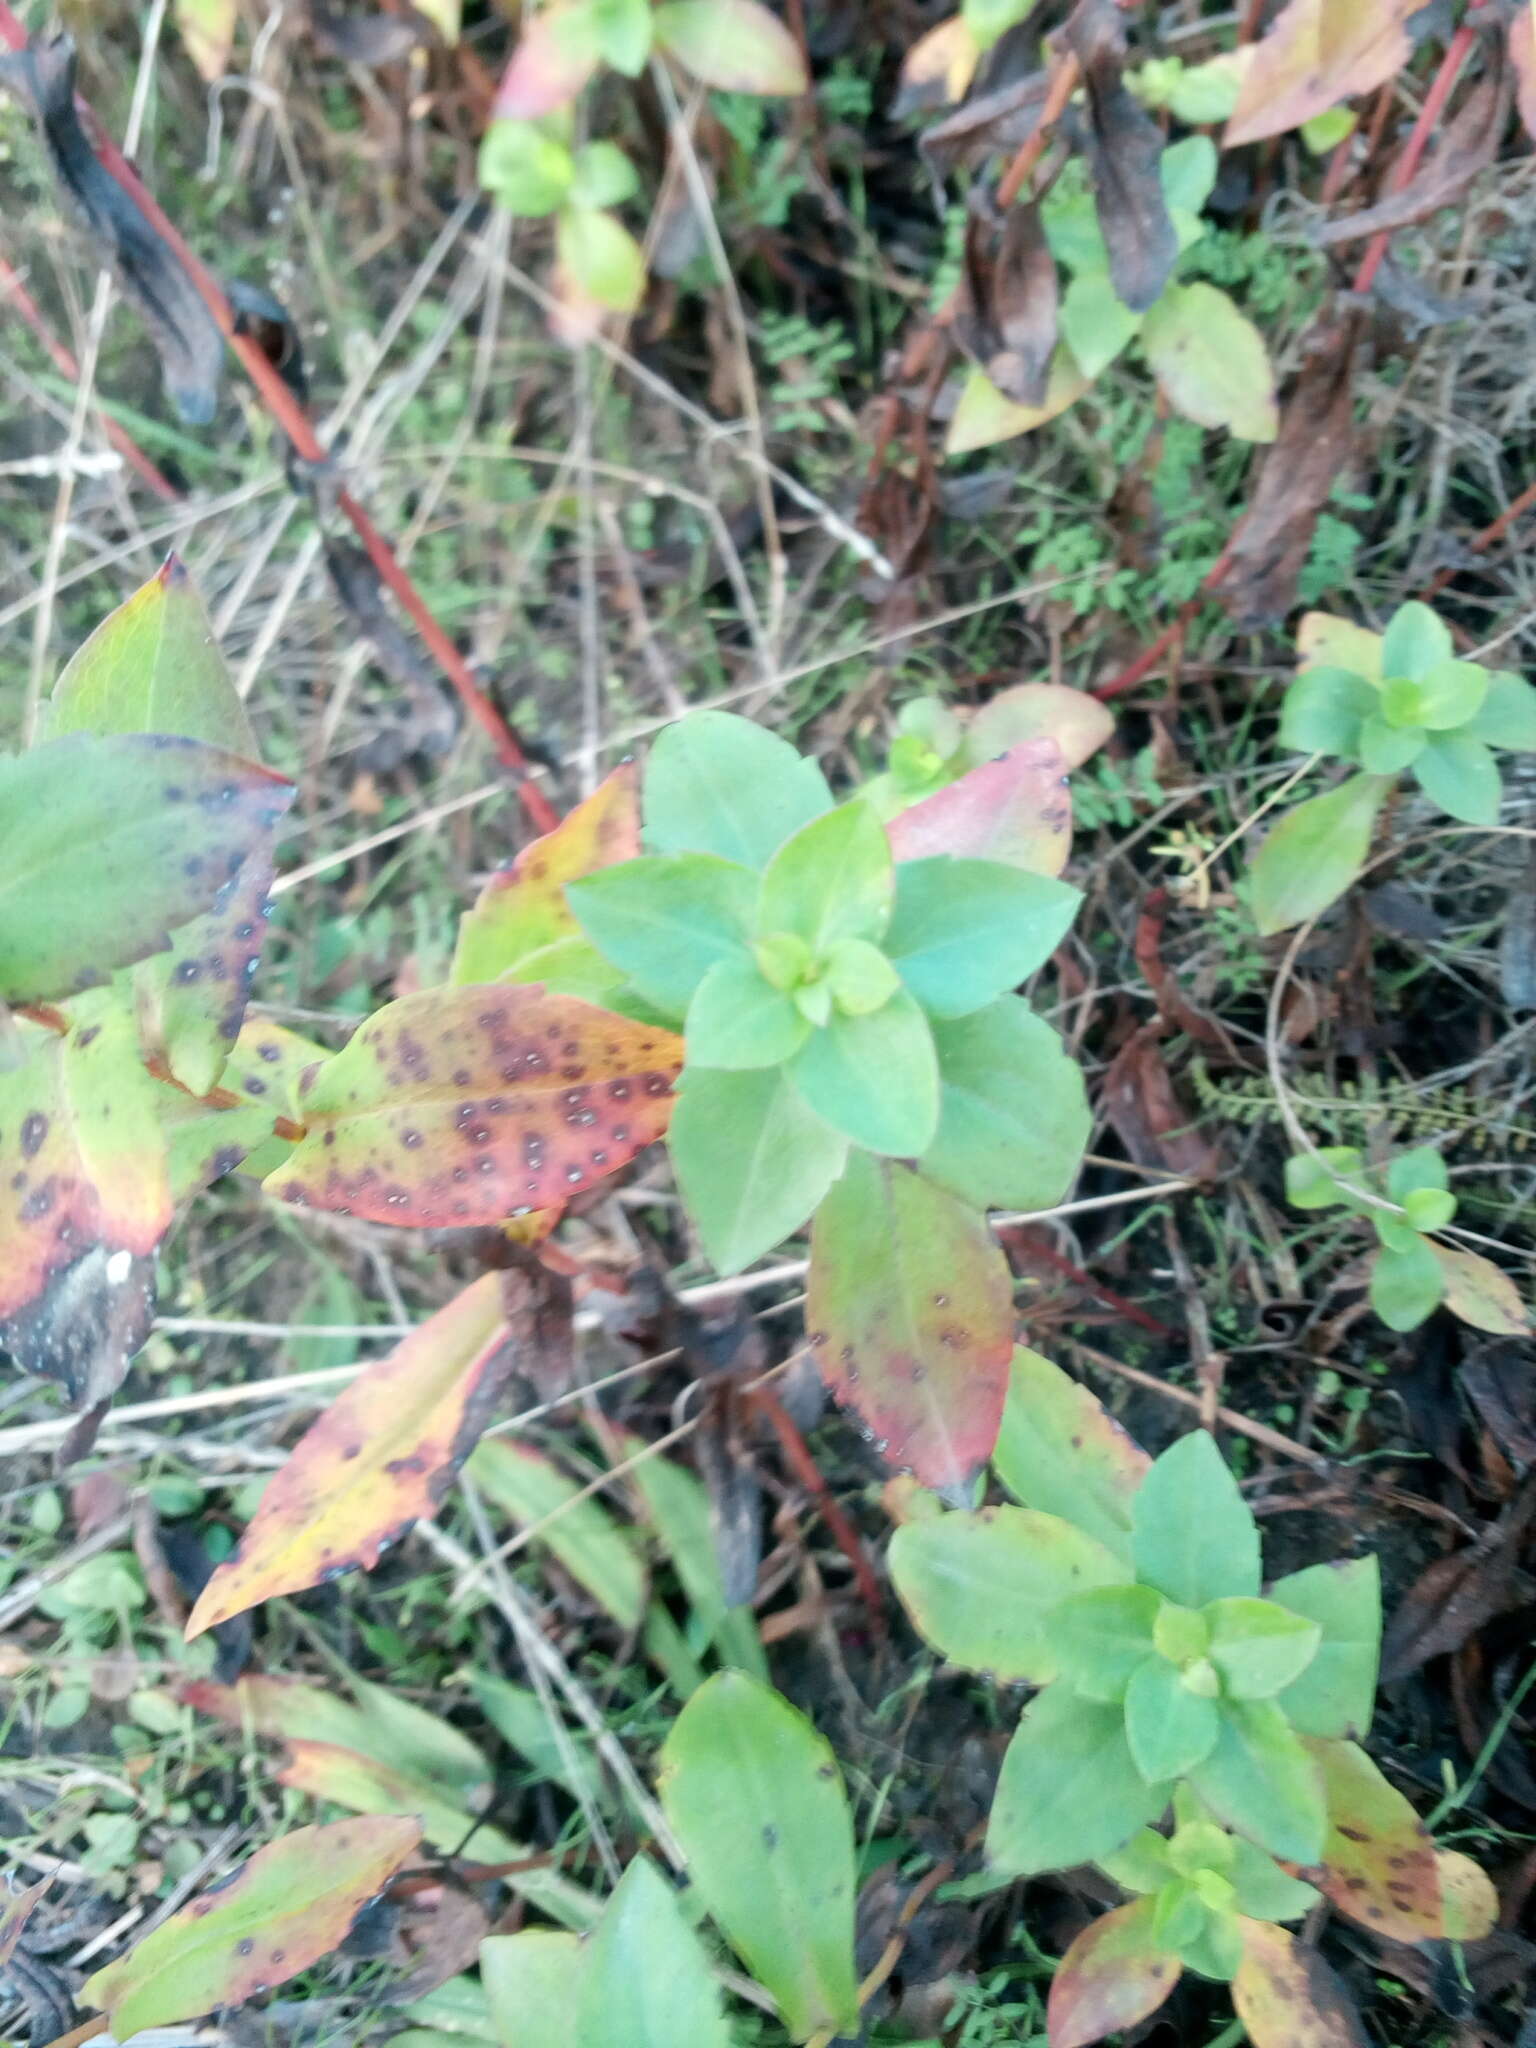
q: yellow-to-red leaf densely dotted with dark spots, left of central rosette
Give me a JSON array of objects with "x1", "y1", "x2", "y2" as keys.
[{"x1": 266, "y1": 985, "x2": 682, "y2": 1229}]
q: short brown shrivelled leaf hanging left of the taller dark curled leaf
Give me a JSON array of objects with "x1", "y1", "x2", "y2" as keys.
[{"x1": 952, "y1": 205, "x2": 1057, "y2": 406}]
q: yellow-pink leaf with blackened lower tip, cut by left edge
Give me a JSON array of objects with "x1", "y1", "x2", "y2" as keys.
[{"x1": 0, "y1": 997, "x2": 172, "y2": 1405}]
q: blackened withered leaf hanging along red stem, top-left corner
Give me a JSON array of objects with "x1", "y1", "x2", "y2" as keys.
[{"x1": 0, "y1": 35, "x2": 223, "y2": 426}]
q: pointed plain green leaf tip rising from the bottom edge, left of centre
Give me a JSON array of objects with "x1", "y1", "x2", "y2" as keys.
[{"x1": 581, "y1": 1855, "x2": 731, "y2": 2048}]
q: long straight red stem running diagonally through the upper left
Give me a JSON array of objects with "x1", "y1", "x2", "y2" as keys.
[{"x1": 0, "y1": 0, "x2": 559, "y2": 831}]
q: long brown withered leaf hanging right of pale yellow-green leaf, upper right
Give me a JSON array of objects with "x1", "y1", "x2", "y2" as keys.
[{"x1": 1219, "y1": 311, "x2": 1360, "y2": 625}]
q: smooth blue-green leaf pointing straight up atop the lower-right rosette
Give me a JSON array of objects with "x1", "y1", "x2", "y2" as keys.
[{"x1": 1130, "y1": 1430, "x2": 1260, "y2": 1608}]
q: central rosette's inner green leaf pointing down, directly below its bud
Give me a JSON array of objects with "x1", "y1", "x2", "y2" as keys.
[{"x1": 788, "y1": 989, "x2": 938, "y2": 1159}]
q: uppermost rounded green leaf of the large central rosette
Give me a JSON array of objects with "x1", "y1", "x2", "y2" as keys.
[{"x1": 643, "y1": 711, "x2": 831, "y2": 868}]
